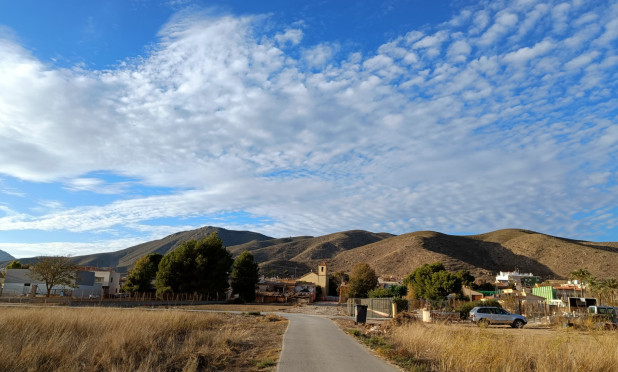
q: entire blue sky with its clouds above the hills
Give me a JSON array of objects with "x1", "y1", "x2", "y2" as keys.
[{"x1": 0, "y1": 0, "x2": 618, "y2": 257}]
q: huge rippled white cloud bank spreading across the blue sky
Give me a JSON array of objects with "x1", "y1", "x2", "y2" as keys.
[{"x1": 0, "y1": 1, "x2": 618, "y2": 256}]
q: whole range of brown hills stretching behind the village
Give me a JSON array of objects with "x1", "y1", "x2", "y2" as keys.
[{"x1": 0, "y1": 226, "x2": 618, "y2": 278}]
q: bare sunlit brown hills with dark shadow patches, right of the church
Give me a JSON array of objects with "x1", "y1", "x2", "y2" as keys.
[{"x1": 327, "y1": 229, "x2": 618, "y2": 278}]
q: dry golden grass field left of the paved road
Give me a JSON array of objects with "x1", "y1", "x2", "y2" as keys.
[{"x1": 0, "y1": 307, "x2": 287, "y2": 371}]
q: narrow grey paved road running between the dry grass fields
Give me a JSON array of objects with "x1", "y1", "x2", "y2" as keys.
[{"x1": 277, "y1": 313, "x2": 399, "y2": 372}]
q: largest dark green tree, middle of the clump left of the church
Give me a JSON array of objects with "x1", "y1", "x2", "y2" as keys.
[{"x1": 155, "y1": 233, "x2": 233, "y2": 299}]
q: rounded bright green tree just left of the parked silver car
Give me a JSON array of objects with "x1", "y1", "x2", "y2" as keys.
[{"x1": 403, "y1": 262, "x2": 461, "y2": 300}]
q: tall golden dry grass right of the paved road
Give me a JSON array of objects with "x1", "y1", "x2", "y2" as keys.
[{"x1": 389, "y1": 323, "x2": 618, "y2": 372}]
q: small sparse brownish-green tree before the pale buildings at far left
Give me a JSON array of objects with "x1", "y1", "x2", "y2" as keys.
[{"x1": 30, "y1": 256, "x2": 78, "y2": 297}]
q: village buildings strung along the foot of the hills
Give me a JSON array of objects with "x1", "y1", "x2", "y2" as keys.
[{"x1": 0, "y1": 262, "x2": 615, "y2": 324}]
